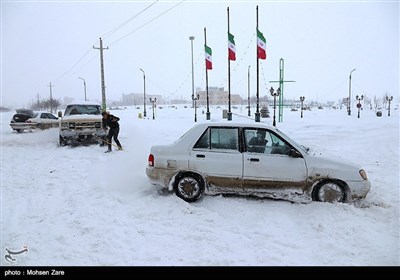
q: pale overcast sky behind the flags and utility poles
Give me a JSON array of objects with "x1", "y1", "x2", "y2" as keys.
[{"x1": 1, "y1": 0, "x2": 400, "y2": 107}]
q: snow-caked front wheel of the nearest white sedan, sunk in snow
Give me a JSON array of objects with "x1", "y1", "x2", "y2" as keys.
[{"x1": 312, "y1": 180, "x2": 347, "y2": 203}]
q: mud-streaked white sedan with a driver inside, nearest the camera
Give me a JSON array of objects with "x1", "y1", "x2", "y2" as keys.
[{"x1": 146, "y1": 122, "x2": 371, "y2": 202}]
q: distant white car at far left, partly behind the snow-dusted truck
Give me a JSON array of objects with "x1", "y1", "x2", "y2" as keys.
[{"x1": 10, "y1": 110, "x2": 60, "y2": 133}]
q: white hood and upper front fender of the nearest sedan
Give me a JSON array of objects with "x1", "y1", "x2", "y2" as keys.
[{"x1": 305, "y1": 154, "x2": 362, "y2": 181}]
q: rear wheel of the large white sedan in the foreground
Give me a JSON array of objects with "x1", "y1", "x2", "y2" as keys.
[{"x1": 174, "y1": 173, "x2": 204, "y2": 202}]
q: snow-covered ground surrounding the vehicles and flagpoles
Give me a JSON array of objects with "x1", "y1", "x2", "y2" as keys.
[{"x1": 0, "y1": 106, "x2": 400, "y2": 266}]
